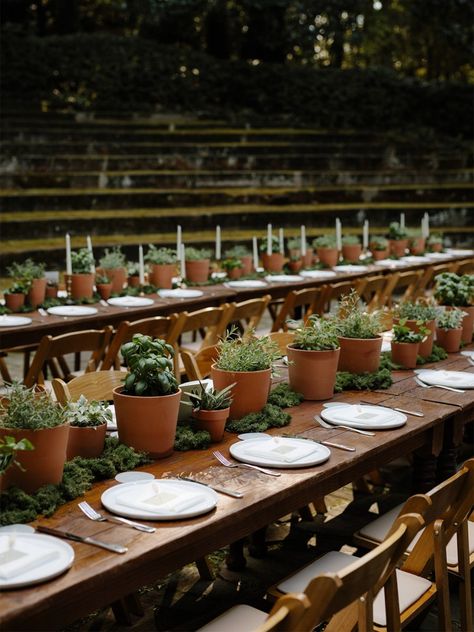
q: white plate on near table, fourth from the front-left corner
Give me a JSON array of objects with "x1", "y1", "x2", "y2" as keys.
[{"x1": 321, "y1": 404, "x2": 407, "y2": 430}]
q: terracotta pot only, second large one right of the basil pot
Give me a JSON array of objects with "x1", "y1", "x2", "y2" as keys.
[{"x1": 286, "y1": 346, "x2": 340, "y2": 400}]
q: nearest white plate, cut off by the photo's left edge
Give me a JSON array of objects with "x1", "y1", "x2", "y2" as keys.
[{"x1": 0, "y1": 532, "x2": 74, "y2": 590}]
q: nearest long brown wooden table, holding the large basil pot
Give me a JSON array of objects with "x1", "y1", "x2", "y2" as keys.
[{"x1": 0, "y1": 346, "x2": 474, "y2": 630}]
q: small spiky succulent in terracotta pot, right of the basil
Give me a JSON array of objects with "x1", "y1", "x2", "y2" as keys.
[{"x1": 188, "y1": 383, "x2": 234, "y2": 442}]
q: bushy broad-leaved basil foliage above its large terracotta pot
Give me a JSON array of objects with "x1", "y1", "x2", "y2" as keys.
[{"x1": 121, "y1": 334, "x2": 178, "y2": 396}]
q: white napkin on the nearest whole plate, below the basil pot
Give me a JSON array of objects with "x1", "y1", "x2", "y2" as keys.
[{"x1": 116, "y1": 481, "x2": 204, "y2": 514}]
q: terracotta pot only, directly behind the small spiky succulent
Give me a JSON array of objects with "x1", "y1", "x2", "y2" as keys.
[{"x1": 211, "y1": 365, "x2": 272, "y2": 419}]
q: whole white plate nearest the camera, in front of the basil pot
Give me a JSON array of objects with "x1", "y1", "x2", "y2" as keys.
[{"x1": 101, "y1": 478, "x2": 217, "y2": 520}]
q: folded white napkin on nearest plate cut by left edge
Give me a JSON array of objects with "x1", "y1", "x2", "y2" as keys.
[{"x1": 0, "y1": 533, "x2": 59, "y2": 580}]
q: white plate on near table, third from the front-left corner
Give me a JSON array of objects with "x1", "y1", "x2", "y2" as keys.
[{"x1": 230, "y1": 437, "x2": 331, "y2": 469}]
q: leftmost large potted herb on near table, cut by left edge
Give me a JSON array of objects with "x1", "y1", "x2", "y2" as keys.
[{"x1": 0, "y1": 383, "x2": 69, "y2": 494}]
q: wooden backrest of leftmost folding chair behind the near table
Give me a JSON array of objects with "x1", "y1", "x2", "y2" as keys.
[{"x1": 24, "y1": 326, "x2": 112, "y2": 387}]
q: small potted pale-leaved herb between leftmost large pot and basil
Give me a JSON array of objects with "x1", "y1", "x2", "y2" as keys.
[{"x1": 66, "y1": 395, "x2": 112, "y2": 461}]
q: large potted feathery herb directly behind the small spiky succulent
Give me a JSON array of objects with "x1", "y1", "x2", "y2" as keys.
[{"x1": 211, "y1": 330, "x2": 281, "y2": 419}]
